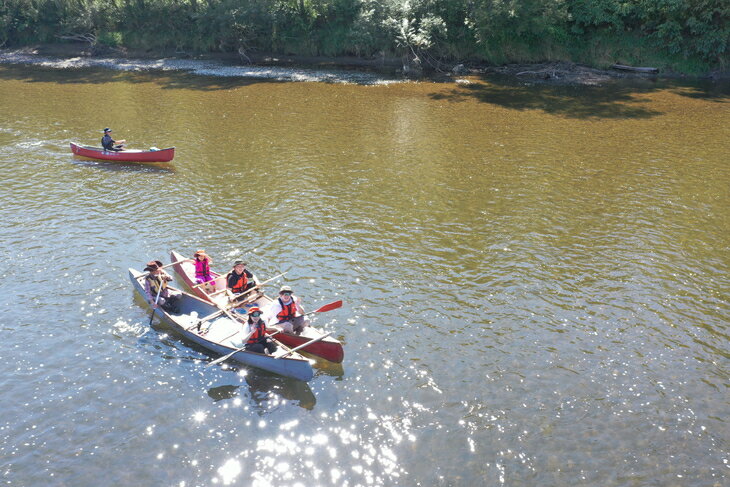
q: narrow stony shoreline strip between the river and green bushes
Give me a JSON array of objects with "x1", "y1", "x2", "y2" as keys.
[{"x1": 0, "y1": 43, "x2": 730, "y2": 85}]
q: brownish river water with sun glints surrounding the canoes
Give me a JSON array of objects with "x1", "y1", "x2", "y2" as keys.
[{"x1": 0, "y1": 65, "x2": 730, "y2": 487}]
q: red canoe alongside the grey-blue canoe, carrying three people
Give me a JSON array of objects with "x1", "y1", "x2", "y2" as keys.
[{"x1": 170, "y1": 250, "x2": 345, "y2": 364}]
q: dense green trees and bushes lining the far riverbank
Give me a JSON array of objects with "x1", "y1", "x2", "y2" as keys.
[{"x1": 0, "y1": 0, "x2": 730, "y2": 73}]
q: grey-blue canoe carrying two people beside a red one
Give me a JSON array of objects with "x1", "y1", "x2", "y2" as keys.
[{"x1": 129, "y1": 269, "x2": 314, "y2": 381}]
